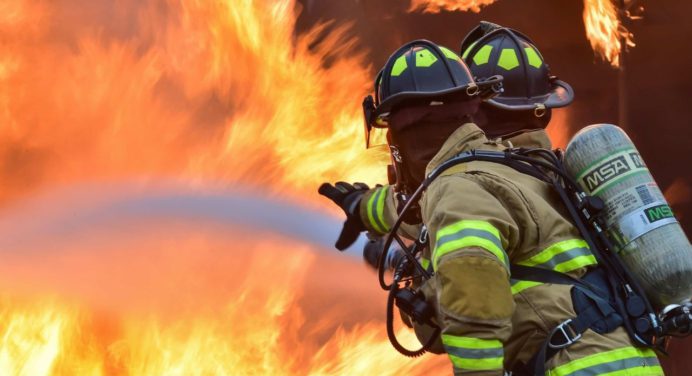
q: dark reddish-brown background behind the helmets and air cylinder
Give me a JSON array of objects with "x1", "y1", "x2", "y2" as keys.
[{"x1": 298, "y1": 0, "x2": 692, "y2": 375}]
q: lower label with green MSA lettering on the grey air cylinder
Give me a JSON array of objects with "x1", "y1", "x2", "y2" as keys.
[{"x1": 610, "y1": 201, "x2": 678, "y2": 247}]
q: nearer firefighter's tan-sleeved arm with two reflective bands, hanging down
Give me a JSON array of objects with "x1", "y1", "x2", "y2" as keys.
[{"x1": 423, "y1": 176, "x2": 518, "y2": 375}]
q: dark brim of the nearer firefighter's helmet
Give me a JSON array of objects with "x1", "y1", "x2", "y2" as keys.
[{"x1": 374, "y1": 76, "x2": 502, "y2": 122}]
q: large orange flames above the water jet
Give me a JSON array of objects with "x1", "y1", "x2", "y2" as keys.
[{"x1": 0, "y1": 0, "x2": 387, "y2": 206}]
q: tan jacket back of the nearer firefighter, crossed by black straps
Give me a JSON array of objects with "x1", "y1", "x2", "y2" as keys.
[{"x1": 455, "y1": 151, "x2": 662, "y2": 375}]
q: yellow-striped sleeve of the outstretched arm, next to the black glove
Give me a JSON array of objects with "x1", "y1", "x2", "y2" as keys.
[{"x1": 360, "y1": 185, "x2": 420, "y2": 239}]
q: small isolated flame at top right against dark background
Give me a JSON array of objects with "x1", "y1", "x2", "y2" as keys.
[{"x1": 584, "y1": 0, "x2": 634, "y2": 67}]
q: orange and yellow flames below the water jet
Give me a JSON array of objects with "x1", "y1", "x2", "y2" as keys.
[{"x1": 0, "y1": 196, "x2": 449, "y2": 376}]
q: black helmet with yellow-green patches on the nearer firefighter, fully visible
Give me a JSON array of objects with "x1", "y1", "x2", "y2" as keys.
[{"x1": 363, "y1": 39, "x2": 502, "y2": 146}]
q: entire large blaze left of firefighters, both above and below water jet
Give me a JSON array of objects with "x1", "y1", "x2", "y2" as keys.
[{"x1": 0, "y1": 0, "x2": 449, "y2": 376}]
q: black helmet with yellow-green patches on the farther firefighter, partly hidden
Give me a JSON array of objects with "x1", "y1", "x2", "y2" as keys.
[{"x1": 461, "y1": 21, "x2": 574, "y2": 117}]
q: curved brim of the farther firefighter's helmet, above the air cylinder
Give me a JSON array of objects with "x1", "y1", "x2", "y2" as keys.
[{"x1": 486, "y1": 79, "x2": 574, "y2": 111}]
